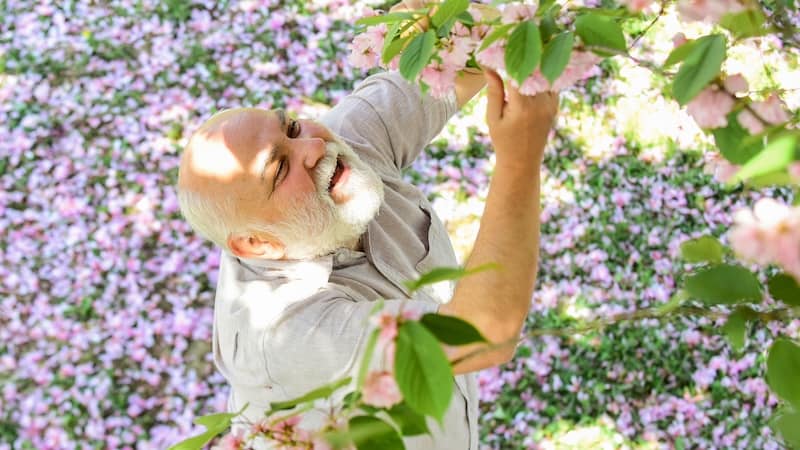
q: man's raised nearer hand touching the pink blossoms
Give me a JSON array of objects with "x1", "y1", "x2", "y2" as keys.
[{"x1": 485, "y1": 69, "x2": 558, "y2": 171}]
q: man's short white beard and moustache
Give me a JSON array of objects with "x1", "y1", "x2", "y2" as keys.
[{"x1": 268, "y1": 138, "x2": 383, "y2": 259}]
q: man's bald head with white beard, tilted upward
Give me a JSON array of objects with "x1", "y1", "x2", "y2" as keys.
[{"x1": 178, "y1": 108, "x2": 383, "y2": 259}]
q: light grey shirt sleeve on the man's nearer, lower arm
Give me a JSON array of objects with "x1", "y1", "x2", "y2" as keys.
[{"x1": 263, "y1": 292, "x2": 439, "y2": 398}]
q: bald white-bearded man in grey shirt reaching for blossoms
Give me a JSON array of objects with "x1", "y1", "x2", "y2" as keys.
[{"x1": 178, "y1": 39, "x2": 557, "y2": 450}]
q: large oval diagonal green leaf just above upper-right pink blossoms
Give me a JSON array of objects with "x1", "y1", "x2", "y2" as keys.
[{"x1": 672, "y1": 34, "x2": 725, "y2": 105}]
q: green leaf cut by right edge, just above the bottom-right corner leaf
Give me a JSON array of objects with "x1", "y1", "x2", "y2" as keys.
[{"x1": 767, "y1": 338, "x2": 800, "y2": 408}]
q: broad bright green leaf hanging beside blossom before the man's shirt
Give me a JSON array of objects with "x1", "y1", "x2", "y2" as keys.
[{"x1": 394, "y1": 322, "x2": 453, "y2": 424}]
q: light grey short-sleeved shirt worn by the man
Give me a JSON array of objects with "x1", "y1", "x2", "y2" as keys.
[{"x1": 213, "y1": 72, "x2": 478, "y2": 450}]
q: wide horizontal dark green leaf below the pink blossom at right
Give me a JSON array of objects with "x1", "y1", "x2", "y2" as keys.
[{"x1": 685, "y1": 264, "x2": 761, "y2": 305}]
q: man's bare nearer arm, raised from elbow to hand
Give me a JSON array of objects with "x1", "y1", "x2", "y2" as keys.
[{"x1": 439, "y1": 71, "x2": 558, "y2": 373}]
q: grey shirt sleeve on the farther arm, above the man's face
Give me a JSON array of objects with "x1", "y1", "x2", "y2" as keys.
[{"x1": 322, "y1": 72, "x2": 458, "y2": 170}]
